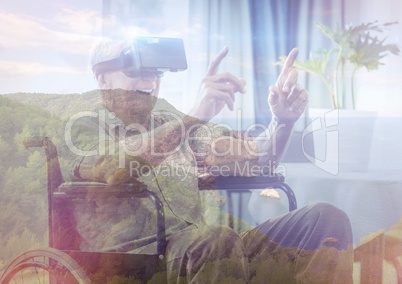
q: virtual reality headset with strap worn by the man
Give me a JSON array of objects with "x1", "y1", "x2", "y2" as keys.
[{"x1": 92, "y1": 37, "x2": 187, "y2": 77}]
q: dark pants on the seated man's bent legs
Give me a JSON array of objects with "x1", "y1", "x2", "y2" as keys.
[{"x1": 166, "y1": 203, "x2": 353, "y2": 283}]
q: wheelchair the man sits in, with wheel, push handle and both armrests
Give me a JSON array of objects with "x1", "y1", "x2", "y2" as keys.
[{"x1": 0, "y1": 137, "x2": 297, "y2": 284}]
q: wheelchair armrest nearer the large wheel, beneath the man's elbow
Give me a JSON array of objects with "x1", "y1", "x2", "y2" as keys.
[{"x1": 53, "y1": 182, "x2": 167, "y2": 256}]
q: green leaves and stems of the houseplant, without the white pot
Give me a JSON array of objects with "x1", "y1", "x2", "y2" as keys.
[{"x1": 278, "y1": 21, "x2": 399, "y2": 109}]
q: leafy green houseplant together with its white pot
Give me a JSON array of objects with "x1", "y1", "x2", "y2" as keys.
[{"x1": 278, "y1": 21, "x2": 399, "y2": 173}]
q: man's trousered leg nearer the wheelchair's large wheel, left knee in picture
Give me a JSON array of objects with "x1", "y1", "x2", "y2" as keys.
[{"x1": 166, "y1": 225, "x2": 248, "y2": 283}]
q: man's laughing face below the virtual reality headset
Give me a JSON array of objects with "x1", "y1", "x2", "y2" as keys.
[{"x1": 98, "y1": 71, "x2": 161, "y2": 124}]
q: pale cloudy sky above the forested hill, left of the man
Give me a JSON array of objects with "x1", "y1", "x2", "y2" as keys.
[{"x1": 0, "y1": 0, "x2": 190, "y2": 94}]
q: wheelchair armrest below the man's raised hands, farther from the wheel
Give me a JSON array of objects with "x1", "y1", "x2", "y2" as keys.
[{"x1": 199, "y1": 174, "x2": 297, "y2": 211}]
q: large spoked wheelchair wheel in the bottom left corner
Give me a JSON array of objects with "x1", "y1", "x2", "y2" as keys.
[{"x1": 0, "y1": 248, "x2": 91, "y2": 284}]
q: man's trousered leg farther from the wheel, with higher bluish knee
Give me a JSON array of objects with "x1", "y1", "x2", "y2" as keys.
[{"x1": 241, "y1": 203, "x2": 353, "y2": 283}]
